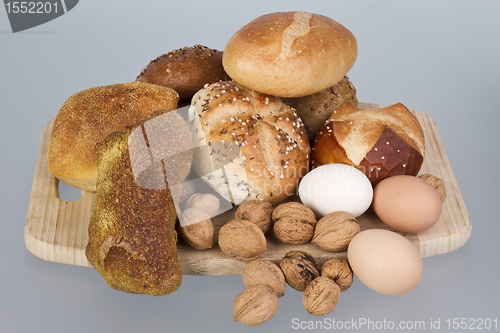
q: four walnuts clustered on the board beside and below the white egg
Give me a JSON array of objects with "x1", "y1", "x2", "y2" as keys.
[{"x1": 218, "y1": 200, "x2": 360, "y2": 261}]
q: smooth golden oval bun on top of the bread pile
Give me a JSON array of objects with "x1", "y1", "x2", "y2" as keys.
[{"x1": 222, "y1": 12, "x2": 358, "y2": 97}]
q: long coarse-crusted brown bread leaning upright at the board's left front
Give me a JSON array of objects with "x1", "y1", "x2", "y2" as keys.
[{"x1": 85, "y1": 110, "x2": 192, "y2": 296}]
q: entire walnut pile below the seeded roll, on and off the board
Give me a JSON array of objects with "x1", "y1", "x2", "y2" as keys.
[{"x1": 180, "y1": 194, "x2": 360, "y2": 326}]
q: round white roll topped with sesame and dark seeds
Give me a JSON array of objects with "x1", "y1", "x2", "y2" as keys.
[{"x1": 189, "y1": 81, "x2": 310, "y2": 204}]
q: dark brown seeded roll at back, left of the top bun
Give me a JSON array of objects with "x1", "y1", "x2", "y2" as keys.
[{"x1": 136, "y1": 45, "x2": 228, "y2": 102}]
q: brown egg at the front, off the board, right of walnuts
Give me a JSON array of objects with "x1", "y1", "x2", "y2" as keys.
[{"x1": 347, "y1": 229, "x2": 423, "y2": 295}]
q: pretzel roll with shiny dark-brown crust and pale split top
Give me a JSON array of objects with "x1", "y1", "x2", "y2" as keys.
[{"x1": 311, "y1": 103, "x2": 425, "y2": 185}]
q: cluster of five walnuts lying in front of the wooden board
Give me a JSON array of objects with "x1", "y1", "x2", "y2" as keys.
[{"x1": 233, "y1": 251, "x2": 353, "y2": 326}]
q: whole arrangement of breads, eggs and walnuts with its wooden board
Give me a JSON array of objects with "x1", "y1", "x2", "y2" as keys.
[{"x1": 25, "y1": 12, "x2": 471, "y2": 326}]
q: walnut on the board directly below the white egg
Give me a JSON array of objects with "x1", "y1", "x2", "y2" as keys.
[{"x1": 311, "y1": 211, "x2": 360, "y2": 252}]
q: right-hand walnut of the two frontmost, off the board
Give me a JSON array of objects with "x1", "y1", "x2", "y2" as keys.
[{"x1": 302, "y1": 276, "x2": 340, "y2": 316}]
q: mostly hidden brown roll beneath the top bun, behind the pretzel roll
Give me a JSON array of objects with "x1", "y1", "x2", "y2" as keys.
[{"x1": 282, "y1": 76, "x2": 358, "y2": 142}]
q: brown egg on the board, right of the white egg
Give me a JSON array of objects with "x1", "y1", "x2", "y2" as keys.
[{"x1": 372, "y1": 175, "x2": 442, "y2": 234}]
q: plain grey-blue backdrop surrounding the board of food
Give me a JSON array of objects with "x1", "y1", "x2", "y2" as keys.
[{"x1": 0, "y1": 0, "x2": 500, "y2": 332}]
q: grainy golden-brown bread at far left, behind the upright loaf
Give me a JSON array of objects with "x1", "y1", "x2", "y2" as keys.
[{"x1": 47, "y1": 82, "x2": 179, "y2": 192}]
